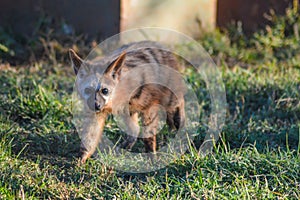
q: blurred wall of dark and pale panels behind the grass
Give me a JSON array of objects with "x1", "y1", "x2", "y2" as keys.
[{"x1": 0, "y1": 0, "x2": 293, "y2": 39}]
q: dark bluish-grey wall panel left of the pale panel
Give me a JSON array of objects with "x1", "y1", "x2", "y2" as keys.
[{"x1": 0, "y1": 0, "x2": 120, "y2": 39}]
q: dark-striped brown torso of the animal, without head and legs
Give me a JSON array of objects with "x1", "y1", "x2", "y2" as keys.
[{"x1": 111, "y1": 41, "x2": 185, "y2": 126}]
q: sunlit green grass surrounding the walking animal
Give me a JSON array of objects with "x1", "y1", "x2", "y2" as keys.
[{"x1": 0, "y1": 5, "x2": 300, "y2": 199}]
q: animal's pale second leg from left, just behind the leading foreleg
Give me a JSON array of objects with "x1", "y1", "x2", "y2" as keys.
[{"x1": 121, "y1": 113, "x2": 140, "y2": 150}]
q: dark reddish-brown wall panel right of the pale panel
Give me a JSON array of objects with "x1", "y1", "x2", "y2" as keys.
[{"x1": 217, "y1": 0, "x2": 293, "y2": 33}]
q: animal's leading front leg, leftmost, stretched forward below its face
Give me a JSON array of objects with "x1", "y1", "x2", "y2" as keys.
[{"x1": 80, "y1": 113, "x2": 107, "y2": 164}]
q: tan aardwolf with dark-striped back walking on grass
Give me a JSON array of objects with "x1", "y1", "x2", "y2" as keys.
[{"x1": 70, "y1": 41, "x2": 185, "y2": 163}]
